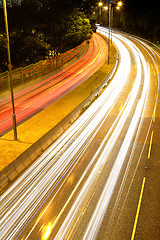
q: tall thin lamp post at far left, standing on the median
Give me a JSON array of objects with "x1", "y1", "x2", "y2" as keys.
[{"x1": 3, "y1": 0, "x2": 17, "y2": 141}]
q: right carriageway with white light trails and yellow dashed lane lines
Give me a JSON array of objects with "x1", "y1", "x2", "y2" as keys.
[{"x1": 0, "y1": 27, "x2": 160, "y2": 240}]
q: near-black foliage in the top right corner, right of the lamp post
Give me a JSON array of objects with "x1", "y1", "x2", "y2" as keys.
[{"x1": 100, "y1": 0, "x2": 160, "y2": 43}]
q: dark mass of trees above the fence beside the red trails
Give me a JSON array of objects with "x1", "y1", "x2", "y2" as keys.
[{"x1": 0, "y1": 0, "x2": 96, "y2": 71}]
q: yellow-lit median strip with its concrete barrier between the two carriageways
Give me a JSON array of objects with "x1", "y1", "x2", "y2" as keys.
[{"x1": 0, "y1": 34, "x2": 118, "y2": 191}]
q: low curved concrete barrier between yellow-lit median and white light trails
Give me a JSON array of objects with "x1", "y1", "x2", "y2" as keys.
[{"x1": 0, "y1": 55, "x2": 118, "y2": 192}]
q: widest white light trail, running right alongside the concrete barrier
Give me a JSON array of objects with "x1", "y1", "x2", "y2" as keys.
[{"x1": 1, "y1": 31, "x2": 130, "y2": 239}]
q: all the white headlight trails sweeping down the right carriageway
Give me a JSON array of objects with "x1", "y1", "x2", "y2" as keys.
[{"x1": 1, "y1": 28, "x2": 158, "y2": 240}]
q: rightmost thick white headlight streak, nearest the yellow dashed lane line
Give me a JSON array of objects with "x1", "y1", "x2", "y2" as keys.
[{"x1": 83, "y1": 46, "x2": 150, "y2": 240}]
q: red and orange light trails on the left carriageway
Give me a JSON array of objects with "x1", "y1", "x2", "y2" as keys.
[{"x1": 0, "y1": 35, "x2": 107, "y2": 132}]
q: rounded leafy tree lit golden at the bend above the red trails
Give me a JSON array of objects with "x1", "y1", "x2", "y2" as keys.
[{"x1": 46, "y1": 9, "x2": 92, "y2": 55}]
